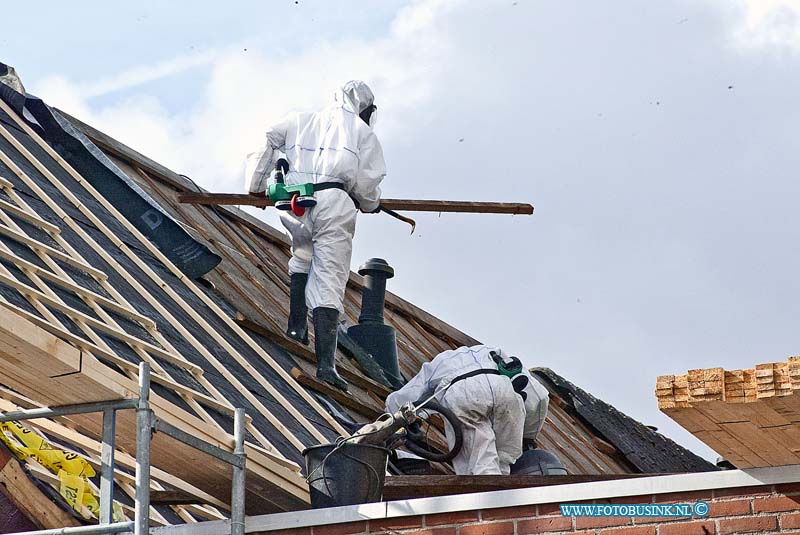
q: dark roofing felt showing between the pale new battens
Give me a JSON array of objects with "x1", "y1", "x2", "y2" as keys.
[{"x1": 0, "y1": 102, "x2": 344, "y2": 464}]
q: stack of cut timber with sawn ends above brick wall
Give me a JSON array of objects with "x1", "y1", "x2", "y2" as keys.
[{"x1": 656, "y1": 357, "x2": 800, "y2": 468}]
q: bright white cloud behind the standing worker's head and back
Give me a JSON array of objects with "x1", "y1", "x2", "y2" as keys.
[{"x1": 33, "y1": 0, "x2": 460, "y2": 195}]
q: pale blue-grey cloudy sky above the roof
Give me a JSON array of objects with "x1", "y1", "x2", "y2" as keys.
[{"x1": 0, "y1": 0, "x2": 800, "y2": 459}]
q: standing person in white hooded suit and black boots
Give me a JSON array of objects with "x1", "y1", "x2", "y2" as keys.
[{"x1": 246, "y1": 81, "x2": 386, "y2": 390}]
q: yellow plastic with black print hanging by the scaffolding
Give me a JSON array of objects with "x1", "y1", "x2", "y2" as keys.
[{"x1": 0, "y1": 422, "x2": 127, "y2": 522}]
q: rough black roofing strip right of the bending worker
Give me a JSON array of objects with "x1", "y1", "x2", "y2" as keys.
[{"x1": 532, "y1": 368, "x2": 717, "y2": 473}]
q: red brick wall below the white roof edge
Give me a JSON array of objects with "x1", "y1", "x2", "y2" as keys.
[{"x1": 272, "y1": 483, "x2": 800, "y2": 535}]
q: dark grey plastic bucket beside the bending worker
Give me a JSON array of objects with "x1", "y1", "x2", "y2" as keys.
[{"x1": 303, "y1": 444, "x2": 389, "y2": 509}]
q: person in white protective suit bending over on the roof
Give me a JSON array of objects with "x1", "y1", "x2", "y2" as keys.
[{"x1": 386, "y1": 345, "x2": 549, "y2": 475}]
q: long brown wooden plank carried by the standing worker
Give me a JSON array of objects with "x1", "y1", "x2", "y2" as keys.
[{"x1": 178, "y1": 191, "x2": 533, "y2": 215}]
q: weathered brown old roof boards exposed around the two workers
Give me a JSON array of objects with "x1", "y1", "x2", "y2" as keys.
[{"x1": 64, "y1": 111, "x2": 714, "y2": 474}]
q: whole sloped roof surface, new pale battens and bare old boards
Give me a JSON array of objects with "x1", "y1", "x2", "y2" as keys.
[{"x1": 0, "y1": 80, "x2": 710, "y2": 528}]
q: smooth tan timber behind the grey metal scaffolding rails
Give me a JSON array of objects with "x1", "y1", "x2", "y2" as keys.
[{"x1": 0, "y1": 307, "x2": 307, "y2": 511}]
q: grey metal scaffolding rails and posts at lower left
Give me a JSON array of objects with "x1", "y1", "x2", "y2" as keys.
[{"x1": 0, "y1": 362, "x2": 247, "y2": 535}]
